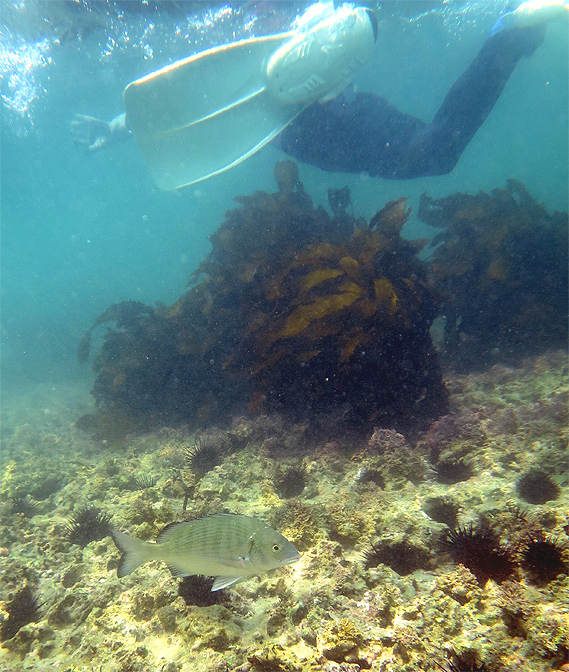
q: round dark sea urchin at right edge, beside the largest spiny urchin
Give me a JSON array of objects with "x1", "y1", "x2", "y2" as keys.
[{"x1": 520, "y1": 530, "x2": 569, "y2": 585}]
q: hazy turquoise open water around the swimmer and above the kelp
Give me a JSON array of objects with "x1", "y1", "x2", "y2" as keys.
[{"x1": 1, "y1": 2, "x2": 568, "y2": 391}]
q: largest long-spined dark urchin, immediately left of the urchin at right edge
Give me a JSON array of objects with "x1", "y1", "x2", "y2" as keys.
[{"x1": 441, "y1": 524, "x2": 516, "y2": 586}]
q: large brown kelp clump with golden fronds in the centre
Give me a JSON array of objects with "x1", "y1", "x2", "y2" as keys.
[{"x1": 80, "y1": 161, "x2": 447, "y2": 438}]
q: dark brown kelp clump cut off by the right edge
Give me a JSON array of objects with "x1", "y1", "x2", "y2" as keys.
[{"x1": 418, "y1": 180, "x2": 569, "y2": 370}]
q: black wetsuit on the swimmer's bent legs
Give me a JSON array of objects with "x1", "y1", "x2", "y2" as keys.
[{"x1": 273, "y1": 25, "x2": 545, "y2": 180}]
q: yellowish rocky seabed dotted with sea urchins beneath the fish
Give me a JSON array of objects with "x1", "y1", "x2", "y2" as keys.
[{"x1": 0, "y1": 352, "x2": 569, "y2": 672}]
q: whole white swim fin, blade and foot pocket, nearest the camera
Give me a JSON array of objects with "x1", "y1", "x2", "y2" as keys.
[{"x1": 124, "y1": 3, "x2": 377, "y2": 190}]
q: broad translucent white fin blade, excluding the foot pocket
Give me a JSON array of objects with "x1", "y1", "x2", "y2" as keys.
[{"x1": 124, "y1": 34, "x2": 296, "y2": 190}]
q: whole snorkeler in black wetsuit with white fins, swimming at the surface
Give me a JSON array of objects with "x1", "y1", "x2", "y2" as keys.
[{"x1": 71, "y1": 0, "x2": 569, "y2": 189}]
